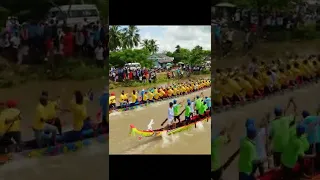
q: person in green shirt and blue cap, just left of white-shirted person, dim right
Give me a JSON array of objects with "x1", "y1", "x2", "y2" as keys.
[{"x1": 238, "y1": 126, "x2": 257, "y2": 180}]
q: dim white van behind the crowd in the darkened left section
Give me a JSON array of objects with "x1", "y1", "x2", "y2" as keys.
[{"x1": 48, "y1": 4, "x2": 100, "y2": 27}]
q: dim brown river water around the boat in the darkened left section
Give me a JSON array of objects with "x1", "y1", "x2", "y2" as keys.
[{"x1": 0, "y1": 80, "x2": 109, "y2": 180}]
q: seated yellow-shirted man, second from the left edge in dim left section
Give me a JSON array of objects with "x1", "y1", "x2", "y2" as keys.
[{"x1": 32, "y1": 96, "x2": 57, "y2": 148}]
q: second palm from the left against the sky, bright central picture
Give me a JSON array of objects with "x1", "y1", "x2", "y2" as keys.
[{"x1": 122, "y1": 26, "x2": 140, "y2": 49}]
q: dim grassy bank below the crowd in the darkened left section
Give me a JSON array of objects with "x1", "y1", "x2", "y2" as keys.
[{"x1": 0, "y1": 57, "x2": 108, "y2": 88}]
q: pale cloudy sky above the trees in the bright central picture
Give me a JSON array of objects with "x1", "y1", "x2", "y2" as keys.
[{"x1": 120, "y1": 26, "x2": 211, "y2": 52}]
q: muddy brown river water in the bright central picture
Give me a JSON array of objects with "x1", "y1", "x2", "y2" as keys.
[{"x1": 109, "y1": 88, "x2": 211, "y2": 154}]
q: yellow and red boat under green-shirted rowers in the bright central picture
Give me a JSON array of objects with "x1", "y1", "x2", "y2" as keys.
[{"x1": 130, "y1": 111, "x2": 211, "y2": 137}]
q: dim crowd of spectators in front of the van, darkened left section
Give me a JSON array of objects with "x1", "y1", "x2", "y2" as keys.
[{"x1": 0, "y1": 17, "x2": 107, "y2": 67}]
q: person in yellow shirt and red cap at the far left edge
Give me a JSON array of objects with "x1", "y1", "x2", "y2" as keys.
[{"x1": 0, "y1": 100, "x2": 21, "y2": 152}]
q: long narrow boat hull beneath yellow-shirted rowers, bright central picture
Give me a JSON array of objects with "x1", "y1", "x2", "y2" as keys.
[{"x1": 109, "y1": 86, "x2": 211, "y2": 114}]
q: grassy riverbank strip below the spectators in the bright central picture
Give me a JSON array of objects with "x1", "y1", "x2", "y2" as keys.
[{"x1": 109, "y1": 71, "x2": 210, "y2": 89}]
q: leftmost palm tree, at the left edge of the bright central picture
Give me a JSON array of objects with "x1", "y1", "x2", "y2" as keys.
[{"x1": 109, "y1": 26, "x2": 123, "y2": 51}]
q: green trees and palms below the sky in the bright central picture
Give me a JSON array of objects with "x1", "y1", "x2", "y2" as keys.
[{"x1": 109, "y1": 26, "x2": 211, "y2": 68}]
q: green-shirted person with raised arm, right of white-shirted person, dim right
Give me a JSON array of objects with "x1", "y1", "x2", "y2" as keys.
[{"x1": 269, "y1": 107, "x2": 295, "y2": 167}]
